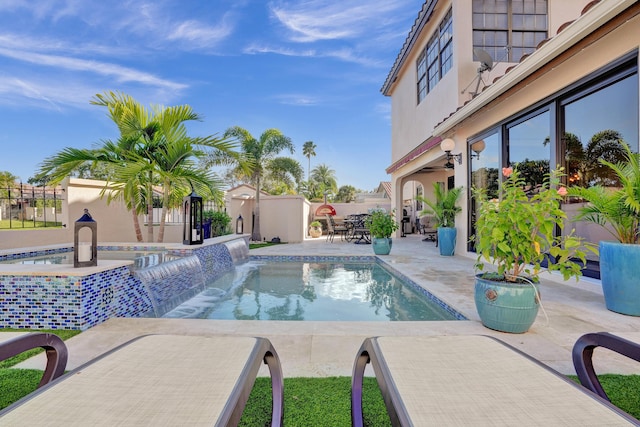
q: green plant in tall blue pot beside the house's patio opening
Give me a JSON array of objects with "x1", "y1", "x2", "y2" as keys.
[{"x1": 417, "y1": 182, "x2": 463, "y2": 256}]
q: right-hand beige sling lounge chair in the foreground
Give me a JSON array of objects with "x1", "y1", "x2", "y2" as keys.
[{"x1": 351, "y1": 335, "x2": 639, "y2": 426}]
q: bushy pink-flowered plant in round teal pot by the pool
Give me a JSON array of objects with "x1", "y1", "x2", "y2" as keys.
[{"x1": 472, "y1": 168, "x2": 586, "y2": 333}]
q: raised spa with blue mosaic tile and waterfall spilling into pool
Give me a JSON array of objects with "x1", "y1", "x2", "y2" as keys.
[{"x1": 0, "y1": 239, "x2": 249, "y2": 330}]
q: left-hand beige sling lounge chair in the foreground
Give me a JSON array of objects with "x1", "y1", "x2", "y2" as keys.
[{"x1": 0, "y1": 335, "x2": 283, "y2": 426}]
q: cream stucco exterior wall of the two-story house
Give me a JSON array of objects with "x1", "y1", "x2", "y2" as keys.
[{"x1": 388, "y1": 0, "x2": 640, "y2": 253}]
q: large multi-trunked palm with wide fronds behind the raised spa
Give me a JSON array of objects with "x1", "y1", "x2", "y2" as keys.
[{"x1": 39, "y1": 92, "x2": 235, "y2": 242}]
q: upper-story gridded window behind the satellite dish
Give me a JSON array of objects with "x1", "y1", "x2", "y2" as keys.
[{"x1": 473, "y1": 0, "x2": 548, "y2": 62}]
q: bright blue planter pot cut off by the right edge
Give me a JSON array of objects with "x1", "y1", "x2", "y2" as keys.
[{"x1": 599, "y1": 242, "x2": 640, "y2": 316}]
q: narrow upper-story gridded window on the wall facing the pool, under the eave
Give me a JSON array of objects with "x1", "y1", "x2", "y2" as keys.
[{"x1": 416, "y1": 10, "x2": 453, "y2": 104}]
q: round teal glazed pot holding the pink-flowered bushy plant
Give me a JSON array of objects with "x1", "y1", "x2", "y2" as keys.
[{"x1": 474, "y1": 274, "x2": 540, "y2": 334}]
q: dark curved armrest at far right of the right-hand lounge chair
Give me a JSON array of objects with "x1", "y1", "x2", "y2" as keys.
[{"x1": 572, "y1": 332, "x2": 640, "y2": 400}]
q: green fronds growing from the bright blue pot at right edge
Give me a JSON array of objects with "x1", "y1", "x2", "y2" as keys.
[{"x1": 568, "y1": 144, "x2": 640, "y2": 244}]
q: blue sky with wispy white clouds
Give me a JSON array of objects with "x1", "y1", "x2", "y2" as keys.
[{"x1": 0, "y1": 0, "x2": 423, "y2": 190}]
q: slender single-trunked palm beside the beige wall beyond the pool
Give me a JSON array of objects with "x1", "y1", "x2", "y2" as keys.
[{"x1": 205, "y1": 126, "x2": 295, "y2": 241}]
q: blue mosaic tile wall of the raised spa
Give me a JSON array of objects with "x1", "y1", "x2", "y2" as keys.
[{"x1": 0, "y1": 244, "x2": 241, "y2": 330}]
